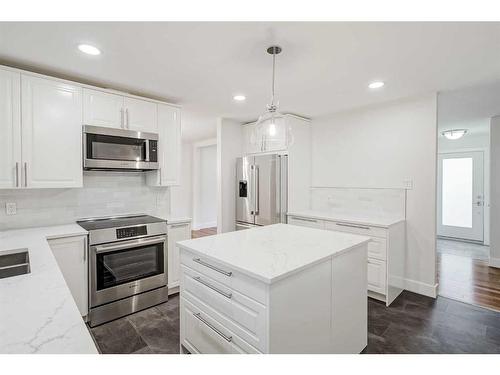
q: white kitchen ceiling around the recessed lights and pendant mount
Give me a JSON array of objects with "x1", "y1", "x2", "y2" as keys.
[{"x1": 0, "y1": 22, "x2": 500, "y2": 140}]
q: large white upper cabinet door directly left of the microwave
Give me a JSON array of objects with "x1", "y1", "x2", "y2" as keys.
[{"x1": 21, "y1": 75, "x2": 83, "y2": 188}]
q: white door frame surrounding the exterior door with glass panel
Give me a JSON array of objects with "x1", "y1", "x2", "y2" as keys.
[{"x1": 436, "y1": 148, "x2": 490, "y2": 245}]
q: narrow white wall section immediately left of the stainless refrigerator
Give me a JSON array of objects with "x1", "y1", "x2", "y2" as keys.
[{"x1": 217, "y1": 118, "x2": 243, "y2": 233}]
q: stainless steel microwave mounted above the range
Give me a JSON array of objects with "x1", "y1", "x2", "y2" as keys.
[{"x1": 83, "y1": 125, "x2": 159, "y2": 171}]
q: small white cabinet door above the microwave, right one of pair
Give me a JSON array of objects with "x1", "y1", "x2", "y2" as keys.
[{"x1": 124, "y1": 97, "x2": 158, "y2": 133}]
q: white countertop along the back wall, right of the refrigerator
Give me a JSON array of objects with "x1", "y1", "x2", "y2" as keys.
[{"x1": 287, "y1": 210, "x2": 405, "y2": 228}]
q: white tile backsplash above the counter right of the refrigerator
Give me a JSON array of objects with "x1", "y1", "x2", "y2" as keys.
[{"x1": 311, "y1": 187, "x2": 406, "y2": 217}]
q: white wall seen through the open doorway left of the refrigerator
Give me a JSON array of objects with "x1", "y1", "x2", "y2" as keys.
[{"x1": 193, "y1": 139, "x2": 217, "y2": 229}]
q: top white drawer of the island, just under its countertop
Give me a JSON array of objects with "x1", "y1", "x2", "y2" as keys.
[{"x1": 181, "y1": 249, "x2": 267, "y2": 305}]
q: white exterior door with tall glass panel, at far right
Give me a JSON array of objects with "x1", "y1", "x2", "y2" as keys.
[{"x1": 437, "y1": 151, "x2": 484, "y2": 242}]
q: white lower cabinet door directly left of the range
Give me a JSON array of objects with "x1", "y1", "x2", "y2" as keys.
[{"x1": 49, "y1": 236, "x2": 88, "y2": 316}]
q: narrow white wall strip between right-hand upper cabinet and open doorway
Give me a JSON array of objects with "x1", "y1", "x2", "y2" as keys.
[{"x1": 170, "y1": 142, "x2": 193, "y2": 218}]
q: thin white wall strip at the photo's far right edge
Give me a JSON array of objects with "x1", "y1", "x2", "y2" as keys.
[{"x1": 490, "y1": 116, "x2": 500, "y2": 268}]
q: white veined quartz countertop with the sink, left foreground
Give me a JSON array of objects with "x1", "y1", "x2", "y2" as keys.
[{"x1": 0, "y1": 224, "x2": 97, "y2": 354}]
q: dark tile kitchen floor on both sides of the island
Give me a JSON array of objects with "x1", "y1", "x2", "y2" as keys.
[{"x1": 91, "y1": 292, "x2": 500, "y2": 354}]
